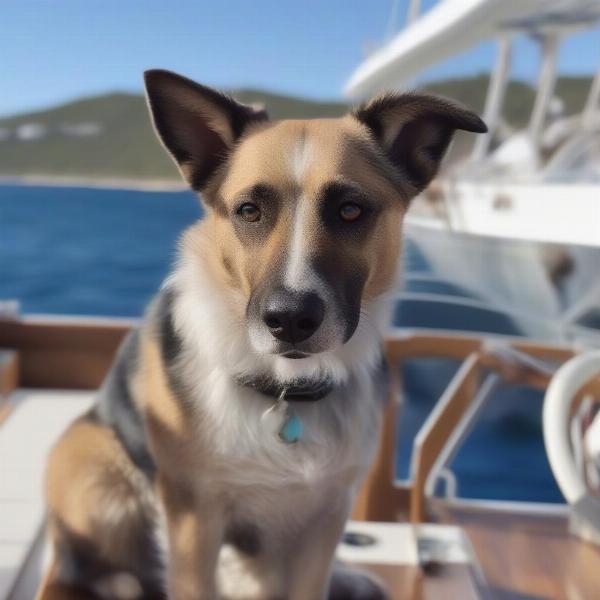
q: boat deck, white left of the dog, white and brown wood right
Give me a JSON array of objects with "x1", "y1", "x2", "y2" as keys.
[{"x1": 0, "y1": 390, "x2": 600, "y2": 600}]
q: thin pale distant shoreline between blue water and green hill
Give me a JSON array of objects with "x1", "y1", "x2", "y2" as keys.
[{"x1": 0, "y1": 175, "x2": 189, "y2": 192}]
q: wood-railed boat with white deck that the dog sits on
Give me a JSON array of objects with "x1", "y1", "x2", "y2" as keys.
[{"x1": 0, "y1": 311, "x2": 600, "y2": 600}]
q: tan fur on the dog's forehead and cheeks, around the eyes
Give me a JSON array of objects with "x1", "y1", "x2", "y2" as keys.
[{"x1": 202, "y1": 116, "x2": 412, "y2": 310}]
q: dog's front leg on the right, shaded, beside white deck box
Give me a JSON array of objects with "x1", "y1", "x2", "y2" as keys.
[{"x1": 288, "y1": 498, "x2": 350, "y2": 600}]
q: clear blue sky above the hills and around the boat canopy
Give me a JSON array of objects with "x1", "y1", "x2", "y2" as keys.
[{"x1": 0, "y1": 0, "x2": 600, "y2": 115}]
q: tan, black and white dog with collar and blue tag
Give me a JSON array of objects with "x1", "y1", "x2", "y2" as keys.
[{"x1": 38, "y1": 70, "x2": 486, "y2": 600}]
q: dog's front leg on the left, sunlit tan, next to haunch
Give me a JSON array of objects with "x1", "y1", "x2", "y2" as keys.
[{"x1": 159, "y1": 480, "x2": 223, "y2": 600}]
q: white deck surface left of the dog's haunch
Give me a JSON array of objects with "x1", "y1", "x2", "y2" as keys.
[{"x1": 0, "y1": 390, "x2": 93, "y2": 600}]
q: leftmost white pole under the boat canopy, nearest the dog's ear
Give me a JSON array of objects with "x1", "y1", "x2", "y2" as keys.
[{"x1": 471, "y1": 35, "x2": 512, "y2": 161}]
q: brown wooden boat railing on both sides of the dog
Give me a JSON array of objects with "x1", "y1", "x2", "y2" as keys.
[{"x1": 0, "y1": 316, "x2": 600, "y2": 522}]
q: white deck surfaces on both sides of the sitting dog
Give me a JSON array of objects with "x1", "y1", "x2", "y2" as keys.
[{"x1": 0, "y1": 390, "x2": 470, "y2": 600}]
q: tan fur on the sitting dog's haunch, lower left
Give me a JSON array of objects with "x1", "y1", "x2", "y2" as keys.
[{"x1": 38, "y1": 416, "x2": 156, "y2": 600}]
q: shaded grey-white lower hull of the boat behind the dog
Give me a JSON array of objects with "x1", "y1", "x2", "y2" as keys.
[{"x1": 405, "y1": 216, "x2": 600, "y2": 340}]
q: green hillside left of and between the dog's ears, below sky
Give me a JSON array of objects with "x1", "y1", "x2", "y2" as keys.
[{"x1": 0, "y1": 90, "x2": 345, "y2": 180}]
